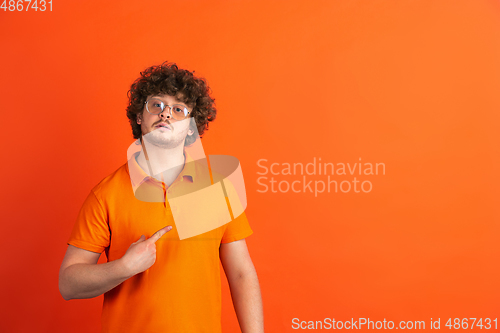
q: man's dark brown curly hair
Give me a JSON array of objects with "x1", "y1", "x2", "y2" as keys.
[{"x1": 127, "y1": 62, "x2": 217, "y2": 146}]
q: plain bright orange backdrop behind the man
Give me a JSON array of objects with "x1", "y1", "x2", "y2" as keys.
[{"x1": 0, "y1": 0, "x2": 500, "y2": 332}]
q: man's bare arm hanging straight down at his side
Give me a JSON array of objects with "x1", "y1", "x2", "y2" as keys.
[{"x1": 219, "y1": 239, "x2": 264, "y2": 333}]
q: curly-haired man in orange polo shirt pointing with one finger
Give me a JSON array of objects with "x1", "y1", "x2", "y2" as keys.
[{"x1": 59, "y1": 63, "x2": 264, "y2": 333}]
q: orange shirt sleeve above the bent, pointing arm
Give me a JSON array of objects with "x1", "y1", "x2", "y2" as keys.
[{"x1": 67, "y1": 191, "x2": 110, "y2": 253}]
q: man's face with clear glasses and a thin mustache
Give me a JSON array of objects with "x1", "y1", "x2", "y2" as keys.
[{"x1": 137, "y1": 95, "x2": 194, "y2": 148}]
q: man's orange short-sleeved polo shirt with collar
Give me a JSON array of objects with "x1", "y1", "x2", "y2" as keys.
[{"x1": 68, "y1": 148, "x2": 253, "y2": 333}]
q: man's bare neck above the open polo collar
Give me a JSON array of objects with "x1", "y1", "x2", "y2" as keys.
[{"x1": 136, "y1": 138, "x2": 185, "y2": 186}]
